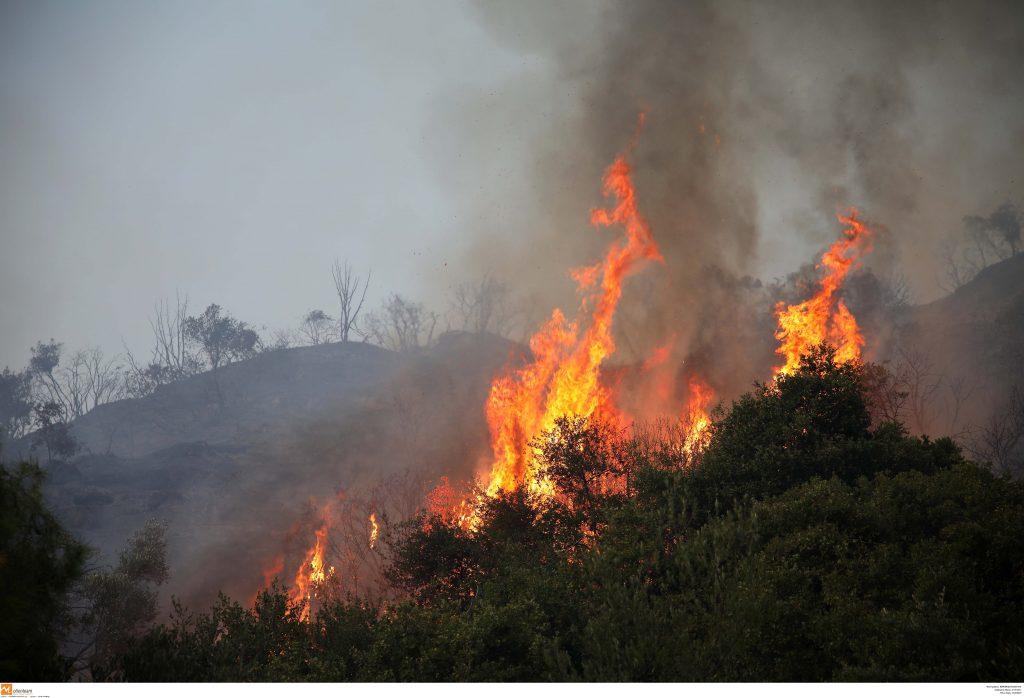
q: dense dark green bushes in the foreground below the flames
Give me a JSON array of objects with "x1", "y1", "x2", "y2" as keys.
[{"x1": 114, "y1": 349, "x2": 1024, "y2": 681}]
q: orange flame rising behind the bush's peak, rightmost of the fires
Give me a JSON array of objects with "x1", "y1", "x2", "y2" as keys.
[{"x1": 775, "y1": 209, "x2": 871, "y2": 376}]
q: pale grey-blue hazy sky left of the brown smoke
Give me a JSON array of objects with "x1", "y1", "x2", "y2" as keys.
[{"x1": 0, "y1": 0, "x2": 544, "y2": 367}]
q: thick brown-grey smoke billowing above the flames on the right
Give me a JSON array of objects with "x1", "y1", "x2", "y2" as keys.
[{"x1": 432, "y1": 0, "x2": 1024, "y2": 380}]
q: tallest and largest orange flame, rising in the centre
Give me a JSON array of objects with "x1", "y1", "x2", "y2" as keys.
[{"x1": 484, "y1": 137, "x2": 662, "y2": 495}]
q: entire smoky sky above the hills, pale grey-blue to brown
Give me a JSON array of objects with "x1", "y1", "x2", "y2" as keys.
[{"x1": 0, "y1": 0, "x2": 1024, "y2": 365}]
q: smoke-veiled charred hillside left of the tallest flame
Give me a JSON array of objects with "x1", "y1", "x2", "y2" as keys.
[{"x1": 37, "y1": 333, "x2": 519, "y2": 602}]
